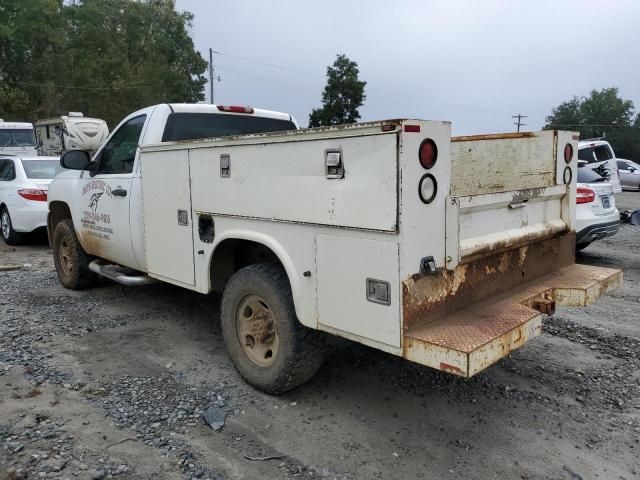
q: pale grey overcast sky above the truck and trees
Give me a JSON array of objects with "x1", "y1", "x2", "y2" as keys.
[{"x1": 176, "y1": 0, "x2": 640, "y2": 134}]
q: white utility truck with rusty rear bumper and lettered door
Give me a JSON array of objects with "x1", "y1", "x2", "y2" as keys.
[{"x1": 48, "y1": 105, "x2": 622, "y2": 393}]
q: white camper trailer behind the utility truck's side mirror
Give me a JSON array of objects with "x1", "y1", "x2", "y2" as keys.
[{"x1": 35, "y1": 112, "x2": 109, "y2": 155}]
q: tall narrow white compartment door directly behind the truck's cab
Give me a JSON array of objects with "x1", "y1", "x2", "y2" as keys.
[{"x1": 141, "y1": 150, "x2": 195, "y2": 285}]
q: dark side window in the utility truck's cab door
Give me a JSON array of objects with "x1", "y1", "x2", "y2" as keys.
[{"x1": 97, "y1": 115, "x2": 147, "y2": 174}]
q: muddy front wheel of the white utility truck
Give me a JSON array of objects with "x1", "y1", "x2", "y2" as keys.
[{"x1": 52, "y1": 219, "x2": 98, "y2": 290}]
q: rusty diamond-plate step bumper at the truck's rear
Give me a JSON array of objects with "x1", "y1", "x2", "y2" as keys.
[{"x1": 403, "y1": 264, "x2": 622, "y2": 378}]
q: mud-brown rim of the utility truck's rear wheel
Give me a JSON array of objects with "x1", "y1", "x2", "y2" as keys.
[{"x1": 236, "y1": 295, "x2": 280, "y2": 367}]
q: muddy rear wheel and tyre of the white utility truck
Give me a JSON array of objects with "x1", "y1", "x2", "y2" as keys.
[{"x1": 221, "y1": 264, "x2": 323, "y2": 394}]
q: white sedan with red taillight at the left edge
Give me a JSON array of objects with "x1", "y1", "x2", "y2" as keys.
[{"x1": 0, "y1": 155, "x2": 64, "y2": 245}]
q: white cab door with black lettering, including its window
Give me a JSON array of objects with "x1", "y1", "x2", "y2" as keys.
[{"x1": 76, "y1": 115, "x2": 146, "y2": 269}]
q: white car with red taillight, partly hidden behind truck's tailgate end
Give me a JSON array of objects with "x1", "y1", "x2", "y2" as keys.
[{"x1": 576, "y1": 166, "x2": 620, "y2": 250}]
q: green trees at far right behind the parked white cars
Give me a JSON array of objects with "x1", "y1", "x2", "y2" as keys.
[{"x1": 544, "y1": 87, "x2": 640, "y2": 160}]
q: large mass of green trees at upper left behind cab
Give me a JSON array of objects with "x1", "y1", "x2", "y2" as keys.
[{"x1": 0, "y1": 0, "x2": 207, "y2": 127}]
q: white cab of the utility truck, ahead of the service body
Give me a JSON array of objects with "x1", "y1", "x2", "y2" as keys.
[{"x1": 49, "y1": 104, "x2": 298, "y2": 271}]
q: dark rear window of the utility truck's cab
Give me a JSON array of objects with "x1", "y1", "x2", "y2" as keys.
[{"x1": 162, "y1": 113, "x2": 296, "y2": 142}]
